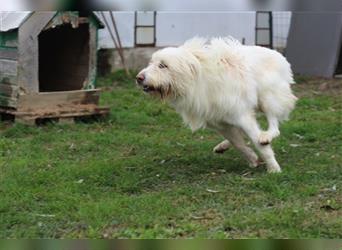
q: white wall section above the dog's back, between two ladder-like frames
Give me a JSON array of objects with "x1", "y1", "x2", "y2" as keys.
[{"x1": 157, "y1": 12, "x2": 255, "y2": 47}]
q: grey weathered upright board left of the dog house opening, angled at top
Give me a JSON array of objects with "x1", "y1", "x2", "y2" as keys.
[{"x1": 18, "y1": 11, "x2": 56, "y2": 93}]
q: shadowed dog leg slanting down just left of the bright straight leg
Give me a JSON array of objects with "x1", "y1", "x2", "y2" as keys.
[{"x1": 221, "y1": 126, "x2": 260, "y2": 167}]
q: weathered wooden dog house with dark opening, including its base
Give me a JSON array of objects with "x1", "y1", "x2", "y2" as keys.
[{"x1": 0, "y1": 11, "x2": 108, "y2": 123}]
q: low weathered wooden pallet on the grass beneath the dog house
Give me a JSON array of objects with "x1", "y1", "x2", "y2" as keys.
[{"x1": 0, "y1": 104, "x2": 109, "y2": 125}]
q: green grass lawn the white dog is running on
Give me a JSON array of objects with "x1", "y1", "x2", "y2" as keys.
[{"x1": 0, "y1": 72, "x2": 342, "y2": 238}]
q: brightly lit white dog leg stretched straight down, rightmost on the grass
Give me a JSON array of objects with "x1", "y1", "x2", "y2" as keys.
[{"x1": 238, "y1": 115, "x2": 281, "y2": 173}]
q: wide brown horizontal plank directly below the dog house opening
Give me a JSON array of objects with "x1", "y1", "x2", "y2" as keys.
[{"x1": 17, "y1": 89, "x2": 100, "y2": 110}]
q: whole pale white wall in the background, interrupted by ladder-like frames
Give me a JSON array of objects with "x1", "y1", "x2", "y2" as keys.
[{"x1": 99, "y1": 11, "x2": 291, "y2": 48}]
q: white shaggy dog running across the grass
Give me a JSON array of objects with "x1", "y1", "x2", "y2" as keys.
[{"x1": 137, "y1": 37, "x2": 297, "y2": 172}]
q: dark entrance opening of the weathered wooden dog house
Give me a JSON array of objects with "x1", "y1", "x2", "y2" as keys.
[{"x1": 38, "y1": 24, "x2": 89, "y2": 92}]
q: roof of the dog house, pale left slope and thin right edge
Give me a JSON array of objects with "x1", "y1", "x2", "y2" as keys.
[{"x1": 0, "y1": 11, "x2": 104, "y2": 32}]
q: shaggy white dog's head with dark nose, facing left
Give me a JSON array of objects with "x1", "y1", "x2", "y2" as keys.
[{"x1": 136, "y1": 47, "x2": 200, "y2": 99}]
